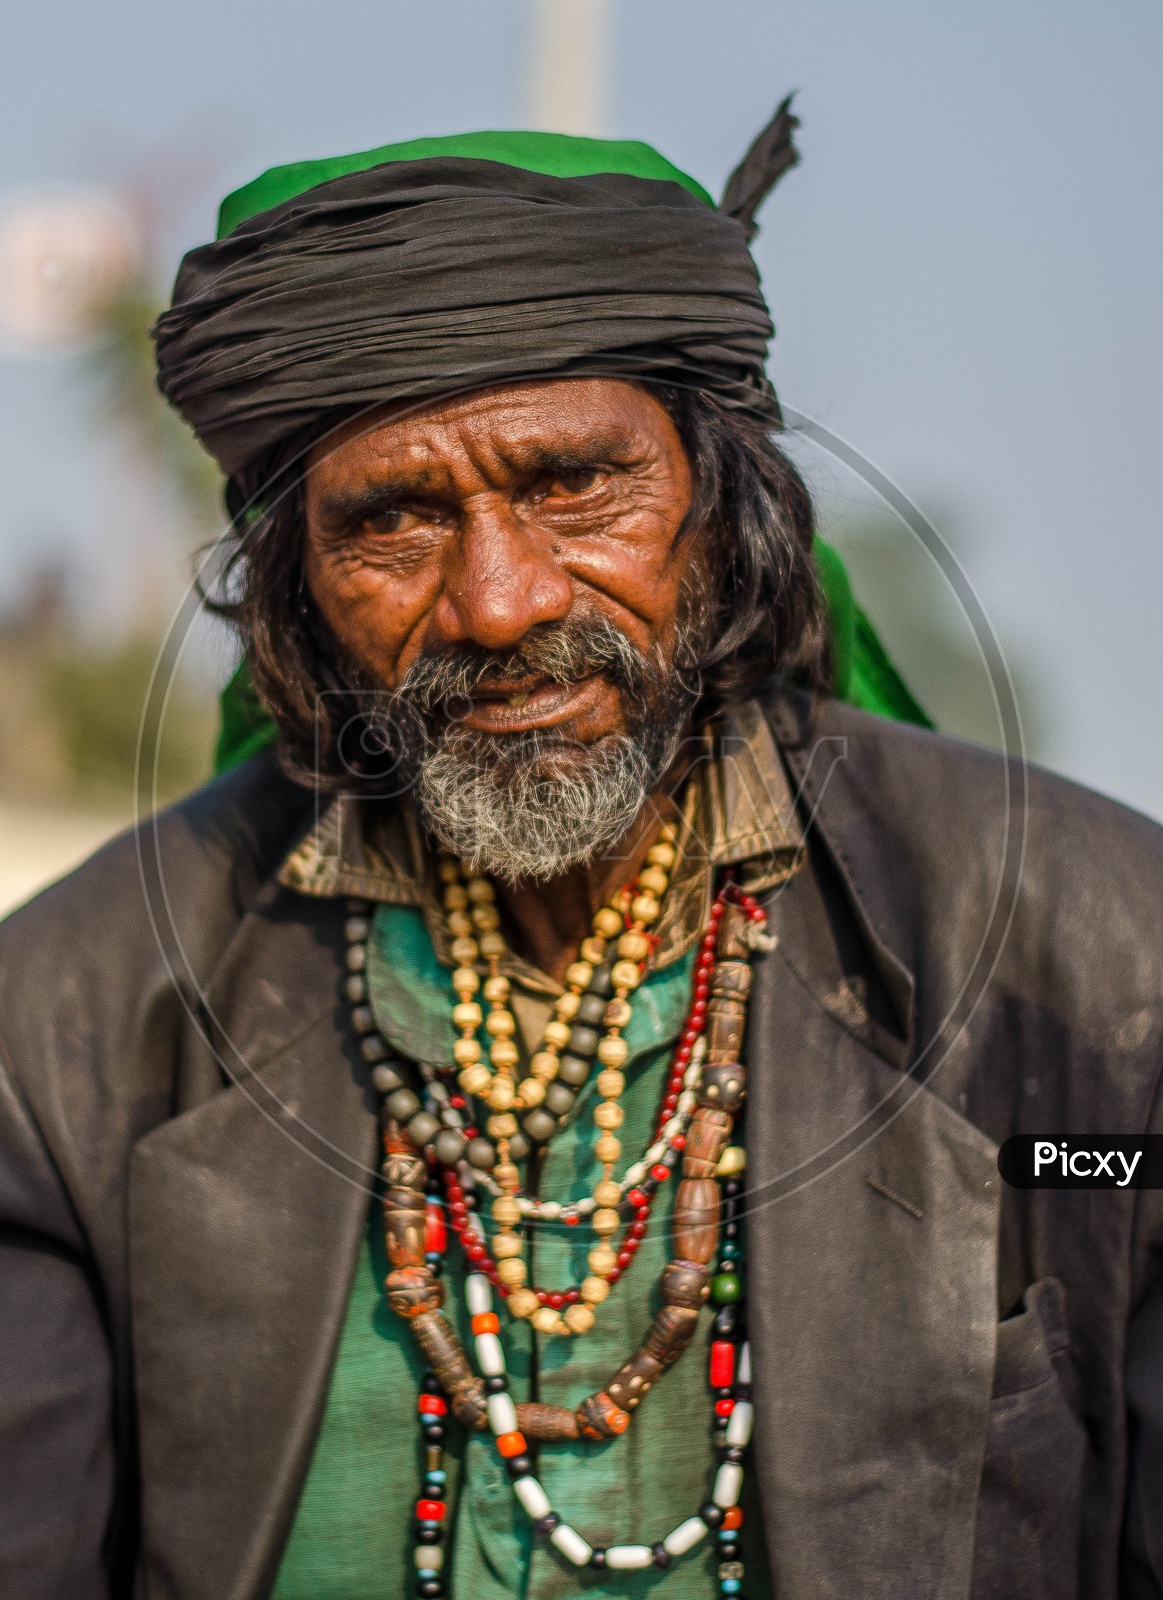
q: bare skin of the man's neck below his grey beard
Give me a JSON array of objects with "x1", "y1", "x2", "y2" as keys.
[{"x1": 496, "y1": 790, "x2": 677, "y2": 982}]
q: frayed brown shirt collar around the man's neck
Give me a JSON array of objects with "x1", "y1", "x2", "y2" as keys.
[{"x1": 278, "y1": 699, "x2": 803, "y2": 994}]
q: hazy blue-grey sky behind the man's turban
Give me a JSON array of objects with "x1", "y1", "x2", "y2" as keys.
[{"x1": 0, "y1": 0, "x2": 1163, "y2": 818}]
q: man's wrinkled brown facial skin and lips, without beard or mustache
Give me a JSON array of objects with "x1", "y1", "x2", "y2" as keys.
[{"x1": 306, "y1": 378, "x2": 699, "y2": 744}]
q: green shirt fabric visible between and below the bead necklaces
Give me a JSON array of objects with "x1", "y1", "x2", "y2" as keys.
[{"x1": 274, "y1": 906, "x2": 771, "y2": 1600}]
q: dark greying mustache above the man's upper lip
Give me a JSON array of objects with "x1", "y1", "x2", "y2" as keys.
[{"x1": 397, "y1": 613, "x2": 653, "y2": 712}]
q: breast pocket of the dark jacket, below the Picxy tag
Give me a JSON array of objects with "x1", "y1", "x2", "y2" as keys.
[{"x1": 971, "y1": 1278, "x2": 1086, "y2": 1600}]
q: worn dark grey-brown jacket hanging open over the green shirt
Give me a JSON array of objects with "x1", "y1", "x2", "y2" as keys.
[{"x1": 0, "y1": 699, "x2": 1163, "y2": 1600}]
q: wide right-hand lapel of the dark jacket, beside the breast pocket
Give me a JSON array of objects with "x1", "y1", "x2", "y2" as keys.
[{"x1": 747, "y1": 707, "x2": 1000, "y2": 1600}]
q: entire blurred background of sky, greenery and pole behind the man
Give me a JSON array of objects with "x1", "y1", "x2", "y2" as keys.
[{"x1": 0, "y1": 0, "x2": 1163, "y2": 909}]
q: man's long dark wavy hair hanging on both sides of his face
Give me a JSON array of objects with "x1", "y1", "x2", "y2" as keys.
[{"x1": 206, "y1": 386, "x2": 830, "y2": 784}]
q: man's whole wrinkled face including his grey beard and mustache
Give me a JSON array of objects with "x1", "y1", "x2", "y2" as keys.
[{"x1": 306, "y1": 379, "x2": 705, "y2": 882}]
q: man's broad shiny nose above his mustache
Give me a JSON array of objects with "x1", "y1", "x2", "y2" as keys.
[{"x1": 434, "y1": 494, "x2": 573, "y2": 650}]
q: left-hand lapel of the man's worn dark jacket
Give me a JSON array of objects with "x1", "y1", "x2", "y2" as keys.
[{"x1": 130, "y1": 893, "x2": 376, "y2": 1600}]
